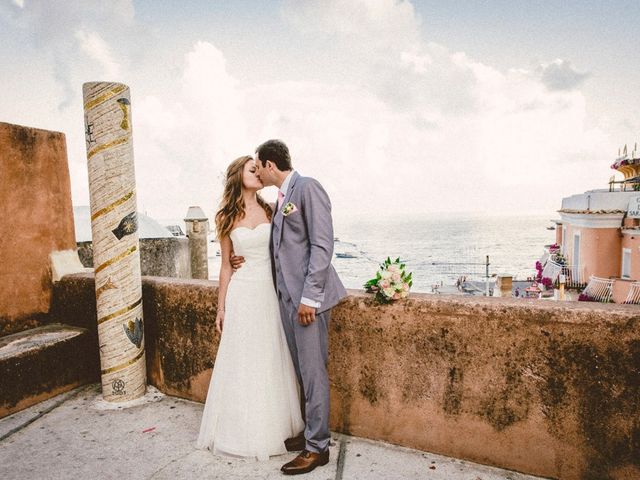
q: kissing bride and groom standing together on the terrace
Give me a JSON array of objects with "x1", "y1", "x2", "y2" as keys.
[{"x1": 197, "y1": 140, "x2": 346, "y2": 475}]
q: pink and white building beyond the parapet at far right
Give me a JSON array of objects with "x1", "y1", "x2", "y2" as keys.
[{"x1": 543, "y1": 146, "x2": 640, "y2": 303}]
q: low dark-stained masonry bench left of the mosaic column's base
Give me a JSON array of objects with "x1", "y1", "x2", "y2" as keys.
[{"x1": 0, "y1": 323, "x2": 100, "y2": 418}]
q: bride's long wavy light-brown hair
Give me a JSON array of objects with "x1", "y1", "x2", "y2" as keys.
[{"x1": 216, "y1": 155, "x2": 272, "y2": 240}]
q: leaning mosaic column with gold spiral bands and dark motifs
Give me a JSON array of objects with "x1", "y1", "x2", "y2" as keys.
[{"x1": 82, "y1": 82, "x2": 147, "y2": 402}]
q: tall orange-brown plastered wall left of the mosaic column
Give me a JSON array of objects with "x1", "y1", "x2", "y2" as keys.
[{"x1": 0, "y1": 123, "x2": 76, "y2": 336}]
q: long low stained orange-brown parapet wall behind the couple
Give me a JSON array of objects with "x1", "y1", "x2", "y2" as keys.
[{"x1": 52, "y1": 274, "x2": 640, "y2": 480}]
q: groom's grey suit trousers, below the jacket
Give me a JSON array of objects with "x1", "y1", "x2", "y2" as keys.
[{"x1": 279, "y1": 300, "x2": 331, "y2": 453}]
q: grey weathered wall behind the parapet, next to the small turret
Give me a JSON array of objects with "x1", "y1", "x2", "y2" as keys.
[{"x1": 78, "y1": 237, "x2": 191, "y2": 278}]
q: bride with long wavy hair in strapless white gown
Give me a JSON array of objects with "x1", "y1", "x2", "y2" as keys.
[{"x1": 197, "y1": 156, "x2": 304, "y2": 460}]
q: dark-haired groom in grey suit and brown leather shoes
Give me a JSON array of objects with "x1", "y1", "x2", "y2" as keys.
[{"x1": 255, "y1": 140, "x2": 347, "y2": 475}]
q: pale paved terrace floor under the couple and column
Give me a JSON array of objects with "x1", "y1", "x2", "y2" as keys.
[{"x1": 0, "y1": 385, "x2": 538, "y2": 480}]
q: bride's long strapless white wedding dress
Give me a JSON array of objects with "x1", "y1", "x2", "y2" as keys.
[{"x1": 197, "y1": 223, "x2": 304, "y2": 460}]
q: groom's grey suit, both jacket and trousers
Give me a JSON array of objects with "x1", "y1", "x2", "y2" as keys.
[{"x1": 270, "y1": 172, "x2": 347, "y2": 453}]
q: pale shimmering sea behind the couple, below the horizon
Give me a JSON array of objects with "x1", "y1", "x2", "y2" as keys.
[{"x1": 198, "y1": 212, "x2": 555, "y2": 293}]
